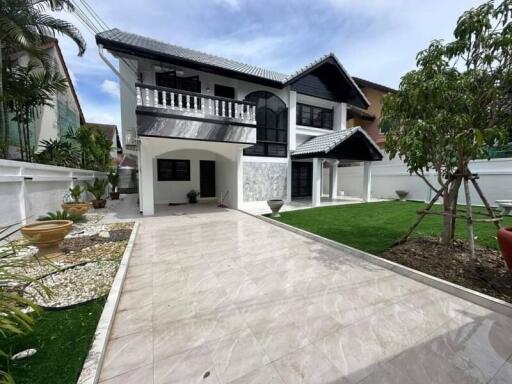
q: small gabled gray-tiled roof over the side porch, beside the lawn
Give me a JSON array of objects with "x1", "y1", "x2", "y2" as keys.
[{"x1": 292, "y1": 127, "x2": 383, "y2": 161}]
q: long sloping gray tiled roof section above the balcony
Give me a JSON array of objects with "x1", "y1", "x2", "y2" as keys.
[{"x1": 96, "y1": 28, "x2": 287, "y2": 83}]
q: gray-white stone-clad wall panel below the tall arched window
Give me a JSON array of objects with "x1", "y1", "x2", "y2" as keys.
[{"x1": 243, "y1": 162, "x2": 288, "y2": 201}]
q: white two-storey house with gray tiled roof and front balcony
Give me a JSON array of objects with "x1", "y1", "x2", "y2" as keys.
[{"x1": 96, "y1": 29, "x2": 382, "y2": 215}]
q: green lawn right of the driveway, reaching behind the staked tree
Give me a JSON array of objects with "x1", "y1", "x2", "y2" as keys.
[{"x1": 270, "y1": 201, "x2": 512, "y2": 255}]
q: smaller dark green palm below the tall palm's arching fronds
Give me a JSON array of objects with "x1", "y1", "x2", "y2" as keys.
[{"x1": 0, "y1": 62, "x2": 68, "y2": 161}]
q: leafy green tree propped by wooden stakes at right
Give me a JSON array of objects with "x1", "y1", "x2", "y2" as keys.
[{"x1": 381, "y1": 0, "x2": 512, "y2": 244}]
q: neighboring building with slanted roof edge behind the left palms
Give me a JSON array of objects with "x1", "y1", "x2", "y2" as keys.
[{"x1": 9, "y1": 39, "x2": 85, "y2": 157}]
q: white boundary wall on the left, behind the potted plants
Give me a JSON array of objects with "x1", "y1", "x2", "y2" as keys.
[{"x1": 0, "y1": 160, "x2": 106, "y2": 226}]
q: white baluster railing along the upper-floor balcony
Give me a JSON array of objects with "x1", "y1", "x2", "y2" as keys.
[{"x1": 135, "y1": 83, "x2": 256, "y2": 124}]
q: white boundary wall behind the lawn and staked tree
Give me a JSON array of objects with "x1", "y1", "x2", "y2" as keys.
[{"x1": 338, "y1": 157, "x2": 512, "y2": 206}]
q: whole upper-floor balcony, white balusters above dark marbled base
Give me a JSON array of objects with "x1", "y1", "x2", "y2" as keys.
[{"x1": 135, "y1": 83, "x2": 256, "y2": 144}]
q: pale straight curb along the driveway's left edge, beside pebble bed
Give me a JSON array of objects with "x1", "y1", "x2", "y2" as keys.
[{"x1": 77, "y1": 221, "x2": 139, "y2": 384}]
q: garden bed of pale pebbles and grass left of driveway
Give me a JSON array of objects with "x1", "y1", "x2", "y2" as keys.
[{"x1": 0, "y1": 213, "x2": 134, "y2": 384}]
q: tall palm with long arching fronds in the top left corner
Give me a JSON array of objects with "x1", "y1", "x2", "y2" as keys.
[{"x1": 0, "y1": 0, "x2": 86, "y2": 157}]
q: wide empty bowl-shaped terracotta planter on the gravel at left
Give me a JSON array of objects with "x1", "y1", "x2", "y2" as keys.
[{"x1": 21, "y1": 220, "x2": 73, "y2": 248}]
